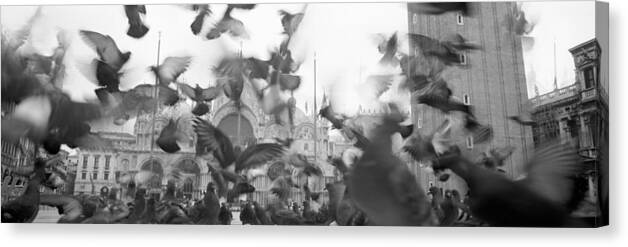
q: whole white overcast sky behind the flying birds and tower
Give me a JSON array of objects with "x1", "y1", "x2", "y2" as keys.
[{"x1": 1, "y1": 1, "x2": 594, "y2": 130}]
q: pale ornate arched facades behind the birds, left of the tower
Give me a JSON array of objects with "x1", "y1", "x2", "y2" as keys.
[{"x1": 74, "y1": 79, "x2": 334, "y2": 204}]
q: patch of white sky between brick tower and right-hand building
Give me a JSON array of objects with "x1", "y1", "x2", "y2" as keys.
[{"x1": 522, "y1": 1, "x2": 595, "y2": 97}]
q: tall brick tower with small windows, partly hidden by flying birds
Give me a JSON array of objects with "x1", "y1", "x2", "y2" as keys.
[{"x1": 408, "y1": 2, "x2": 534, "y2": 194}]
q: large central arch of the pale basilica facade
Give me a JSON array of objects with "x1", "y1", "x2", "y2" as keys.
[{"x1": 218, "y1": 113, "x2": 256, "y2": 146}]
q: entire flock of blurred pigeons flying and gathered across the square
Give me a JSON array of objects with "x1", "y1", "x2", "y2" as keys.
[{"x1": 2, "y1": 3, "x2": 582, "y2": 227}]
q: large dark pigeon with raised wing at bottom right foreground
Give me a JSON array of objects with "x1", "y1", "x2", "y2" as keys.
[{"x1": 434, "y1": 143, "x2": 582, "y2": 227}]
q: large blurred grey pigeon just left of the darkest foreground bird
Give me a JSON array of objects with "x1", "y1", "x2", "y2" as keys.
[{"x1": 349, "y1": 110, "x2": 435, "y2": 226}]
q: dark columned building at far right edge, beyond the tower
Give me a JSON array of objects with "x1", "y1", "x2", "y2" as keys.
[{"x1": 531, "y1": 39, "x2": 609, "y2": 224}]
